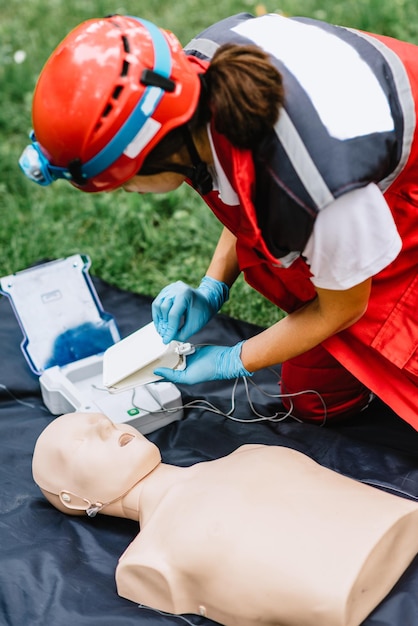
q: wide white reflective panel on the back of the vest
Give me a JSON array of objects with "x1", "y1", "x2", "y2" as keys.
[{"x1": 232, "y1": 14, "x2": 394, "y2": 140}]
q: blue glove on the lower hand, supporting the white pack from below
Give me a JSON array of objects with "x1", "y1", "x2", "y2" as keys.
[{"x1": 154, "y1": 341, "x2": 252, "y2": 385}]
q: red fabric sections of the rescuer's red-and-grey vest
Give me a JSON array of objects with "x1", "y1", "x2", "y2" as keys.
[{"x1": 200, "y1": 35, "x2": 418, "y2": 430}]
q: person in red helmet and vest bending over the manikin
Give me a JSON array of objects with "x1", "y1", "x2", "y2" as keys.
[{"x1": 20, "y1": 14, "x2": 418, "y2": 428}]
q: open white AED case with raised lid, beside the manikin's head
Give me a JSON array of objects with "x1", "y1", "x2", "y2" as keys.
[{"x1": 0, "y1": 254, "x2": 183, "y2": 434}]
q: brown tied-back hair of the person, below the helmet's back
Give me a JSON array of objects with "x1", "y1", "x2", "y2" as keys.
[{"x1": 141, "y1": 44, "x2": 284, "y2": 173}]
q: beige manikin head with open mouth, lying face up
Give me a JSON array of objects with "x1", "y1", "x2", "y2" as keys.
[{"x1": 32, "y1": 413, "x2": 161, "y2": 516}]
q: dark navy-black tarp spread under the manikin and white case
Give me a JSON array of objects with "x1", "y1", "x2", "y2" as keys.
[{"x1": 0, "y1": 280, "x2": 418, "y2": 626}]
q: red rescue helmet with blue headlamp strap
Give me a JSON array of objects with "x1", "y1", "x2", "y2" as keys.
[{"x1": 25, "y1": 15, "x2": 202, "y2": 192}]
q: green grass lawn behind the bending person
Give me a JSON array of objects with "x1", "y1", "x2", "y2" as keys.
[{"x1": 0, "y1": 0, "x2": 418, "y2": 325}]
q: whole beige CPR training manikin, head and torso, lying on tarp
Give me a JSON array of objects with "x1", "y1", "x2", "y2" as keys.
[{"x1": 33, "y1": 413, "x2": 418, "y2": 626}]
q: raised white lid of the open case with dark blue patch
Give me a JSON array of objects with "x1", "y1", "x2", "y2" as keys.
[{"x1": 0, "y1": 254, "x2": 120, "y2": 375}]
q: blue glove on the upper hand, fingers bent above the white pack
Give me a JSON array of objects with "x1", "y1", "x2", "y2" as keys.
[{"x1": 152, "y1": 276, "x2": 229, "y2": 344}]
